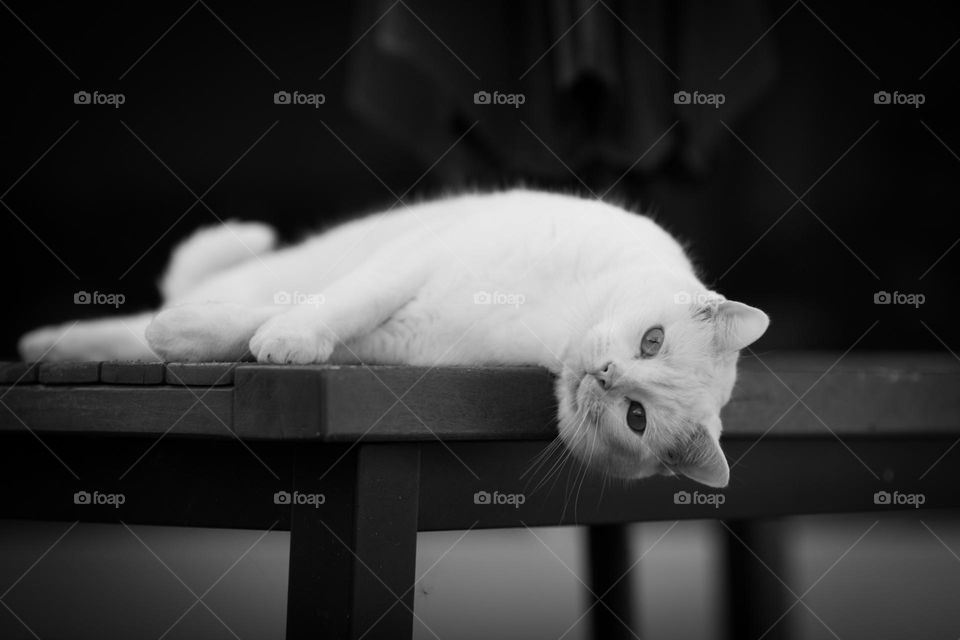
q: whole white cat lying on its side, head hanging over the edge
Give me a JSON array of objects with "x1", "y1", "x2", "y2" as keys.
[{"x1": 20, "y1": 190, "x2": 769, "y2": 487}]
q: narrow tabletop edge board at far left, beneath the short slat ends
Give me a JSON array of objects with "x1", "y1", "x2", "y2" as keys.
[{"x1": 0, "y1": 385, "x2": 233, "y2": 438}]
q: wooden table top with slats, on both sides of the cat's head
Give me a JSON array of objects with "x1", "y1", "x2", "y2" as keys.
[{"x1": 0, "y1": 352, "x2": 960, "y2": 442}]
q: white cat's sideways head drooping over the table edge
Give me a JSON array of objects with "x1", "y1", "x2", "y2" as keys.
[{"x1": 557, "y1": 278, "x2": 770, "y2": 487}]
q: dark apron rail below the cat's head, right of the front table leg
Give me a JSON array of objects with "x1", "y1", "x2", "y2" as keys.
[{"x1": 419, "y1": 436, "x2": 960, "y2": 531}]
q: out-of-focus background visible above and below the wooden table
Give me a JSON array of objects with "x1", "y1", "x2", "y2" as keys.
[{"x1": 0, "y1": 0, "x2": 960, "y2": 638}]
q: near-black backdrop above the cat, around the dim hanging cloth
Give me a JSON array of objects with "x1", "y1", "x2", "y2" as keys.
[{"x1": 0, "y1": 2, "x2": 960, "y2": 358}]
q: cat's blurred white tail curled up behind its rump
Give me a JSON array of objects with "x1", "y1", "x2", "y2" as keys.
[{"x1": 160, "y1": 220, "x2": 277, "y2": 304}]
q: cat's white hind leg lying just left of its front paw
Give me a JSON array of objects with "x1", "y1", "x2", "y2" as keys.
[{"x1": 145, "y1": 302, "x2": 286, "y2": 362}]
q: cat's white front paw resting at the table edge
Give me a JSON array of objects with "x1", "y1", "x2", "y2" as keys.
[{"x1": 250, "y1": 314, "x2": 337, "y2": 364}]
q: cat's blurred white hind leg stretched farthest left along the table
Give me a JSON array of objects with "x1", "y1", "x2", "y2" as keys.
[{"x1": 18, "y1": 312, "x2": 158, "y2": 362}]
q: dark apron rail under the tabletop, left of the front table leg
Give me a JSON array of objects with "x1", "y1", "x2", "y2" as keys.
[{"x1": 0, "y1": 436, "x2": 290, "y2": 530}]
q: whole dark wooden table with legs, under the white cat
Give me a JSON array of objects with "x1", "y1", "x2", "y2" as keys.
[{"x1": 0, "y1": 353, "x2": 960, "y2": 639}]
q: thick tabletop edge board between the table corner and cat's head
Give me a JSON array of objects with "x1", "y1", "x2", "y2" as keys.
[{"x1": 236, "y1": 365, "x2": 554, "y2": 441}]
